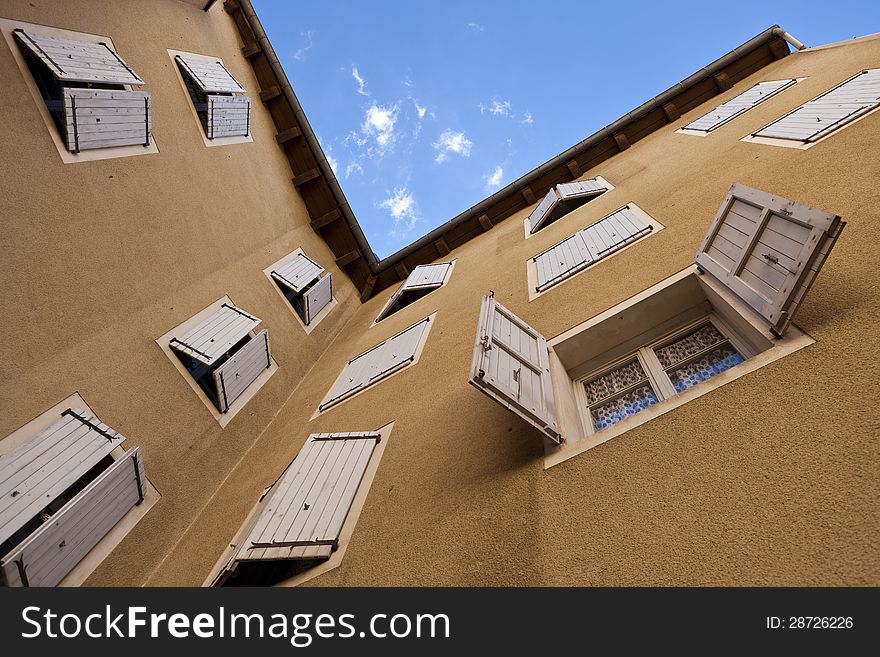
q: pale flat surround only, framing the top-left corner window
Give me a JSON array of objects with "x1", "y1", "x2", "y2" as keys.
[{"x1": 0, "y1": 18, "x2": 159, "y2": 164}]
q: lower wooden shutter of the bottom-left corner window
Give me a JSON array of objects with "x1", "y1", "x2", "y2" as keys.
[{"x1": 0, "y1": 447, "x2": 146, "y2": 586}]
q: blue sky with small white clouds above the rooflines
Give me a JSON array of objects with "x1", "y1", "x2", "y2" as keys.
[{"x1": 253, "y1": 0, "x2": 880, "y2": 258}]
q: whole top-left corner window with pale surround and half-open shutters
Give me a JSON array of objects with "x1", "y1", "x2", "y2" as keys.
[{"x1": 0, "y1": 20, "x2": 157, "y2": 162}]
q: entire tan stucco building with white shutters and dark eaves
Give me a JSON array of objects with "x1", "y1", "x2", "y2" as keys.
[{"x1": 0, "y1": 0, "x2": 880, "y2": 586}]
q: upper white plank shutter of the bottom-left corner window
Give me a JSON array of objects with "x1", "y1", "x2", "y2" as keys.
[{"x1": 0, "y1": 408, "x2": 125, "y2": 543}]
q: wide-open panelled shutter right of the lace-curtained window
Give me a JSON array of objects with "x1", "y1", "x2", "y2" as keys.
[{"x1": 696, "y1": 183, "x2": 846, "y2": 335}]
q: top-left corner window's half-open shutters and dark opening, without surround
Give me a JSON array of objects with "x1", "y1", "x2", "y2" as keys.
[{"x1": 13, "y1": 28, "x2": 152, "y2": 153}]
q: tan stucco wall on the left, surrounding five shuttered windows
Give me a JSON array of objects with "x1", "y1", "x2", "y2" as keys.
[{"x1": 0, "y1": 0, "x2": 360, "y2": 584}]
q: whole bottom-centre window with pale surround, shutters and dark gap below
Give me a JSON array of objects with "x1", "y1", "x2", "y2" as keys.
[{"x1": 208, "y1": 425, "x2": 392, "y2": 586}]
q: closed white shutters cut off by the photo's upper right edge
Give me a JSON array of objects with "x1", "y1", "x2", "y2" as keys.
[{"x1": 753, "y1": 69, "x2": 880, "y2": 143}]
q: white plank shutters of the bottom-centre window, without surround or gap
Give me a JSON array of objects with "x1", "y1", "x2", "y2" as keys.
[{"x1": 235, "y1": 433, "x2": 380, "y2": 561}]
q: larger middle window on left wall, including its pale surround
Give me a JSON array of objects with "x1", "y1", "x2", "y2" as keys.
[{"x1": 157, "y1": 297, "x2": 277, "y2": 426}]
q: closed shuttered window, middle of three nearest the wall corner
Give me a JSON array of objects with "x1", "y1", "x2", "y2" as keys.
[{"x1": 318, "y1": 315, "x2": 434, "y2": 412}]
